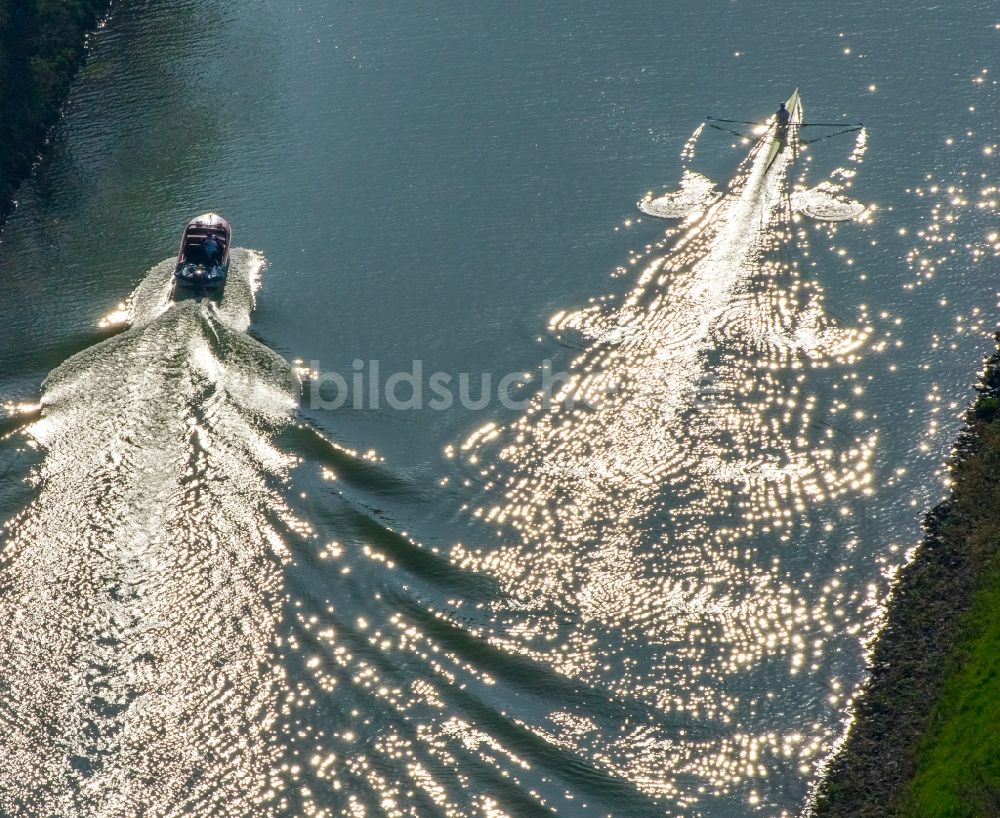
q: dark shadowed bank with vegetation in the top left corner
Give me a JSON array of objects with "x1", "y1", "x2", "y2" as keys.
[{"x1": 0, "y1": 0, "x2": 109, "y2": 221}]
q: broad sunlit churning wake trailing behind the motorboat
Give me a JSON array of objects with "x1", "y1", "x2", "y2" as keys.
[{"x1": 0, "y1": 250, "x2": 298, "y2": 818}]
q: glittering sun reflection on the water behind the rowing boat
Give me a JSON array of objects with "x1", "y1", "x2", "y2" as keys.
[{"x1": 434, "y1": 92, "x2": 878, "y2": 807}]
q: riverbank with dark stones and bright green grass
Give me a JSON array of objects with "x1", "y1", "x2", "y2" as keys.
[{"x1": 816, "y1": 336, "x2": 1000, "y2": 818}]
